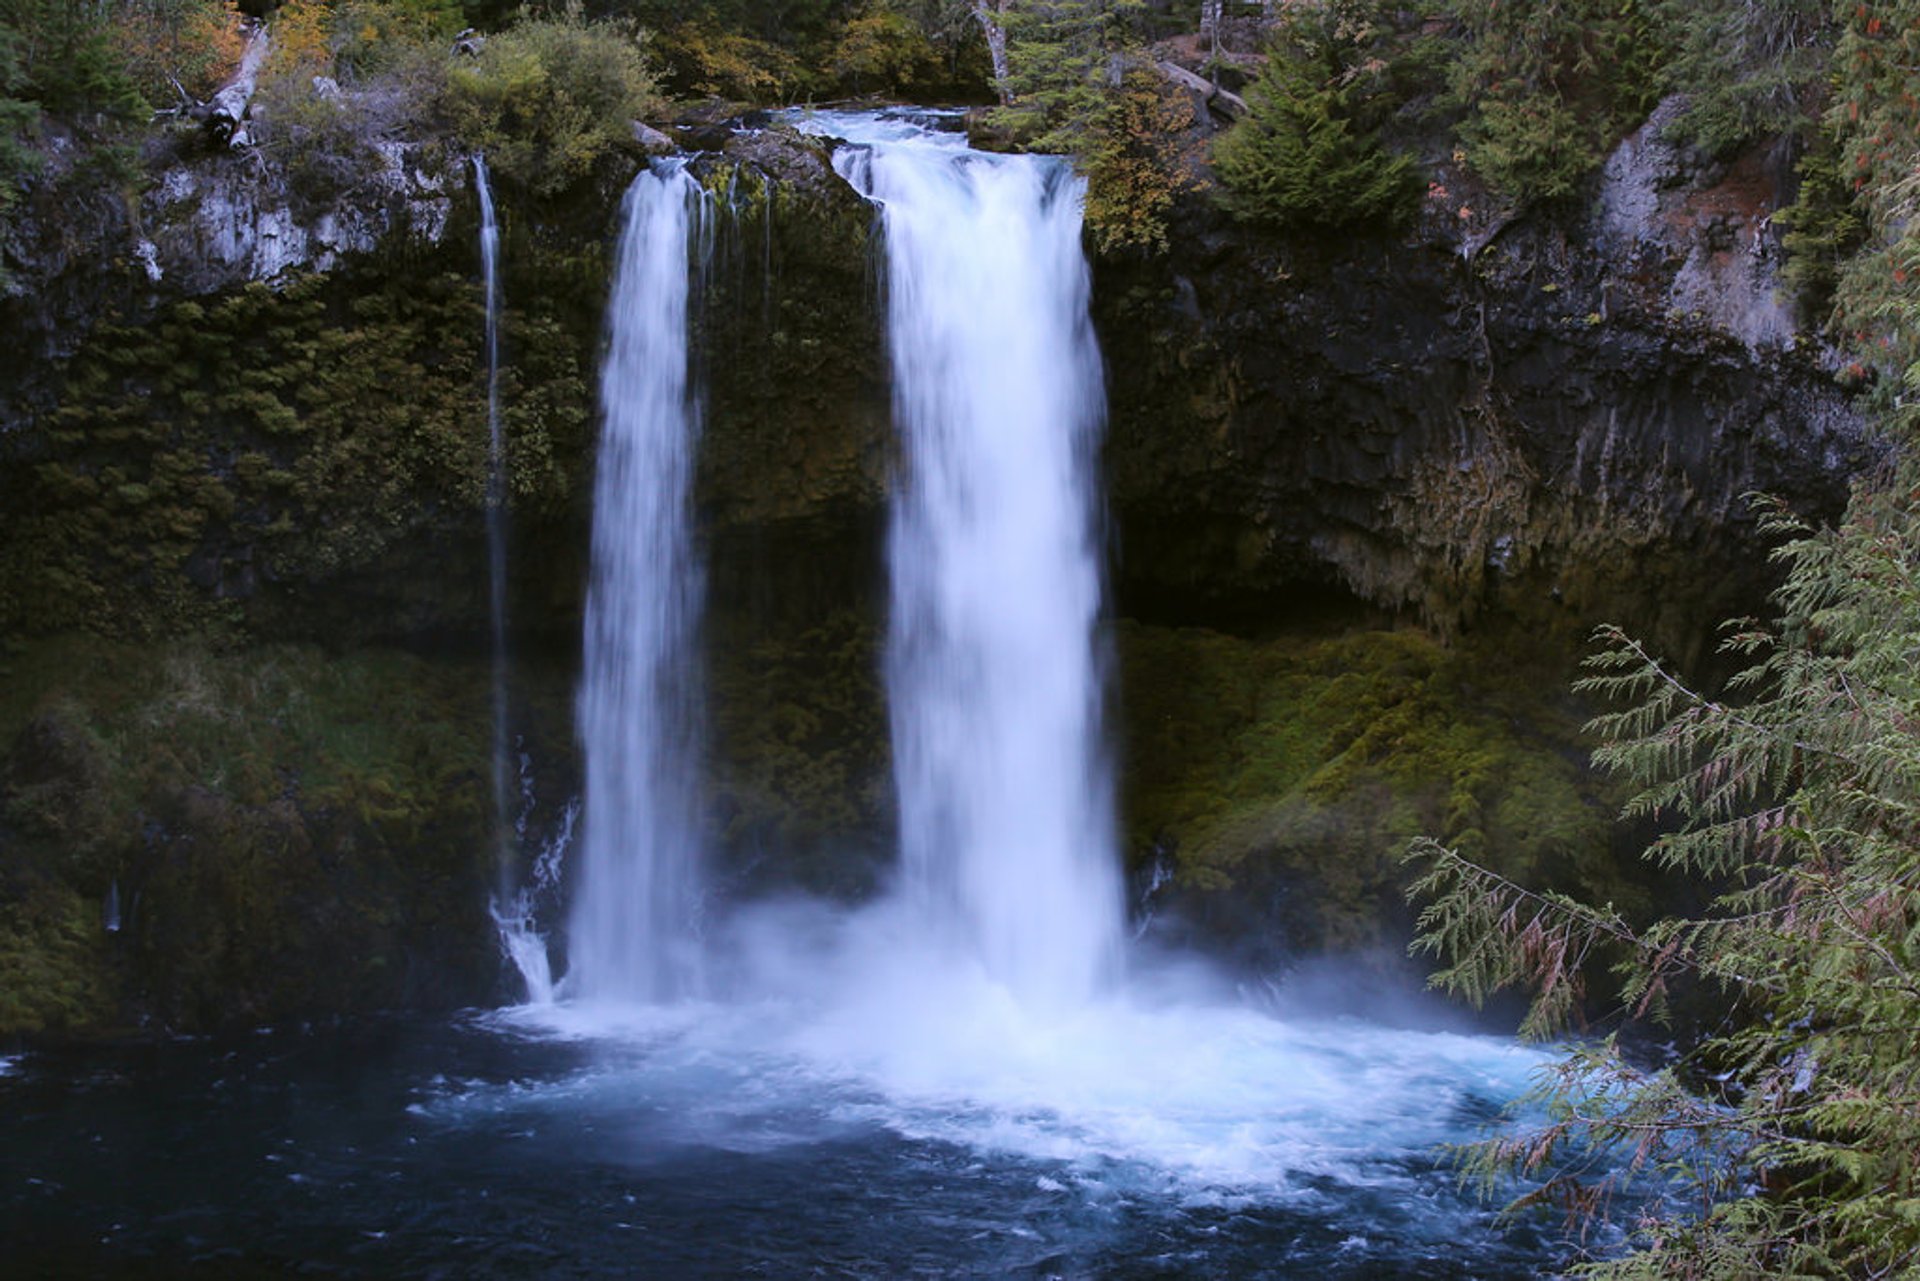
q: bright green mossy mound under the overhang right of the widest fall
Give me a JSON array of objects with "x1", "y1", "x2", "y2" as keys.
[{"x1": 1119, "y1": 624, "x2": 1624, "y2": 945}]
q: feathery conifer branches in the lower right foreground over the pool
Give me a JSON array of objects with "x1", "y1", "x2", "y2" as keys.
[{"x1": 1413, "y1": 409, "x2": 1920, "y2": 1277}]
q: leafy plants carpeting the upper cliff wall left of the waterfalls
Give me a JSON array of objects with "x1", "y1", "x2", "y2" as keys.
[{"x1": 0, "y1": 246, "x2": 603, "y2": 634}]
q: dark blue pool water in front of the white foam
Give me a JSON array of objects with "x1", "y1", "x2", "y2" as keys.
[{"x1": 0, "y1": 1020, "x2": 1553, "y2": 1277}]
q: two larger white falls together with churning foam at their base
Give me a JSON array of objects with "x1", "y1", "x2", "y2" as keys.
[{"x1": 495, "y1": 122, "x2": 1540, "y2": 1252}]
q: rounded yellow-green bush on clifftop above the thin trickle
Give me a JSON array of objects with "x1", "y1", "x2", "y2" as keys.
[{"x1": 447, "y1": 15, "x2": 657, "y2": 196}]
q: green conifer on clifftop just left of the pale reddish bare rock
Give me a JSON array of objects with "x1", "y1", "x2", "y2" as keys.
[{"x1": 1448, "y1": 0, "x2": 1665, "y2": 205}]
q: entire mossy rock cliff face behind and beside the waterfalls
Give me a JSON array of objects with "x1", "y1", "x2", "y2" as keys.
[{"x1": 0, "y1": 107, "x2": 1866, "y2": 1031}]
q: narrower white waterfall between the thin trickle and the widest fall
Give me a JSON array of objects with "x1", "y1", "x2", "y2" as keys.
[{"x1": 568, "y1": 161, "x2": 708, "y2": 1001}]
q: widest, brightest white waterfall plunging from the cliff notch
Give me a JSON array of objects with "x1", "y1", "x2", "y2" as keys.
[{"x1": 822, "y1": 117, "x2": 1123, "y2": 1006}]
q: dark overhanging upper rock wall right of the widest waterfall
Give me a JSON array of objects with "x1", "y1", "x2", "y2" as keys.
[{"x1": 1098, "y1": 97, "x2": 1864, "y2": 657}]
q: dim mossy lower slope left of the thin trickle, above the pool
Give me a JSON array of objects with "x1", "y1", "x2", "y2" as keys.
[{"x1": 0, "y1": 636, "x2": 566, "y2": 1035}]
